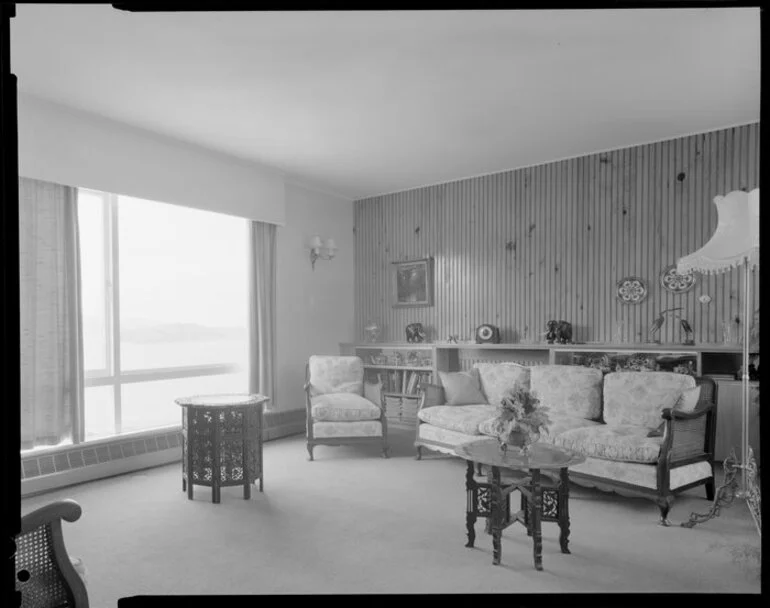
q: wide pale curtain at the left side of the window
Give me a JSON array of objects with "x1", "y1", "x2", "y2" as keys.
[{"x1": 19, "y1": 178, "x2": 83, "y2": 450}]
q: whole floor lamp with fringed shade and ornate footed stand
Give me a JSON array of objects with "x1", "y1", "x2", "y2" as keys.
[{"x1": 677, "y1": 188, "x2": 762, "y2": 537}]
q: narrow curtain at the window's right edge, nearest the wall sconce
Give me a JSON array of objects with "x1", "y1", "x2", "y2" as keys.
[{"x1": 249, "y1": 221, "x2": 277, "y2": 407}]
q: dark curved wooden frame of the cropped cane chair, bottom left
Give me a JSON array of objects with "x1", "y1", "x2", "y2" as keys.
[{"x1": 19, "y1": 499, "x2": 88, "y2": 608}]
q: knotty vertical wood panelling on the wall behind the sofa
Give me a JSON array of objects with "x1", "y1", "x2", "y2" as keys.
[{"x1": 355, "y1": 123, "x2": 759, "y2": 343}]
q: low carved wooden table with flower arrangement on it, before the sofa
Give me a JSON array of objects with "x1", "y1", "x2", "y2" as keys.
[{"x1": 455, "y1": 437, "x2": 585, "y2": 570}]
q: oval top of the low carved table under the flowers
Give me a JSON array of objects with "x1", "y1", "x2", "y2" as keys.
[{"x1": 455, "y1": 437, "x2": 585, "y2": 470}]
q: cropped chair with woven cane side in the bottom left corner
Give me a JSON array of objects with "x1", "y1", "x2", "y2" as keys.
[{"x1": 15, "y1": 499, "x2": 88, "y2": 608}]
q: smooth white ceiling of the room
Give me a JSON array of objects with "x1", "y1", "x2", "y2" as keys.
[{"x1": 11, "y1": 4, "x2": 760, "y2": 198}]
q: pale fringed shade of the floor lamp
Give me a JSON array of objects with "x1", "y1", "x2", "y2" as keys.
[{"x1": 676, "y1": 188, "x2": 759, "y2": 274}]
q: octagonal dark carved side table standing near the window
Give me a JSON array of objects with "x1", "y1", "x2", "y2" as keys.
[{"x1": 175, "y1": 394, "x2": 268, "y2": 503}]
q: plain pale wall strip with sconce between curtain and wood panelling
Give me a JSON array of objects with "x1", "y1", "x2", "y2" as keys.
[{"x1": 276, "y1": 182, "x2": 355, "y2": 410}]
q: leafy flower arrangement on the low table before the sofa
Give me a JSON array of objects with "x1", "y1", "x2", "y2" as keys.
[{"x1": 488, "y1": 386, "x2": 551, "y2": 452}]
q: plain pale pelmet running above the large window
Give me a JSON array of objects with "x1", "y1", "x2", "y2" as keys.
[{"x1": 19, "y1": 94, "x2": 284, "y2": 224}]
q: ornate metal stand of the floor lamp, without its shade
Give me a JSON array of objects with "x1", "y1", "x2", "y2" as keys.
[{"x1": 681, "y1": 259, "x2": 762, "y2": 538}]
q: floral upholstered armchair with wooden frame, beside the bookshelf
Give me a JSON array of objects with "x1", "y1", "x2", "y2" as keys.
[{"x1": 305, "y1": 355, "x2": 390, "y2": 460}]
